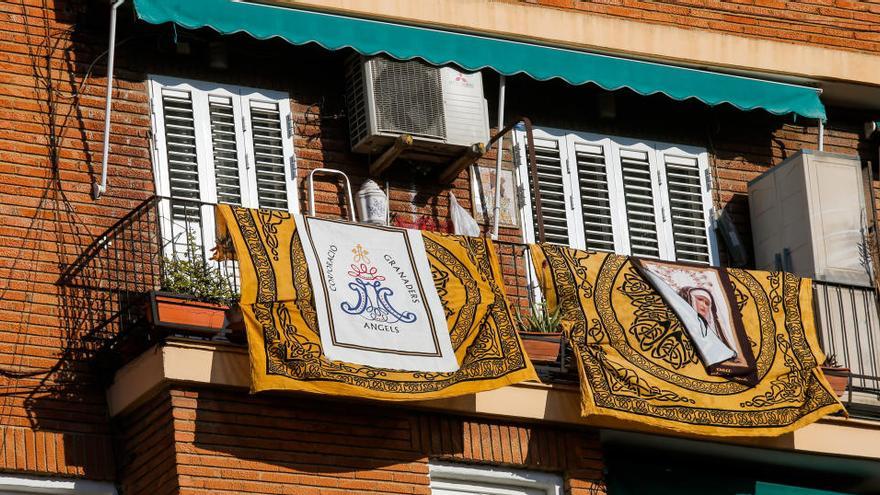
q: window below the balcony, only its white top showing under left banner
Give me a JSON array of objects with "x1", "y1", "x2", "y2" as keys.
[{"x1": 430, "y1": 462, "x2": 563, "y2": 495}]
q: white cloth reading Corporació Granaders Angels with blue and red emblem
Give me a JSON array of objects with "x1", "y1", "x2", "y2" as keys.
[{"x1": 296, "y1": 216, "x2": 458, "y2": 372}]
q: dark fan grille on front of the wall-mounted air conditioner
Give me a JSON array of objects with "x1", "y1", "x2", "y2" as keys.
[{"x1": 371, "y1": 58, "x2": 446, "y2": 139}]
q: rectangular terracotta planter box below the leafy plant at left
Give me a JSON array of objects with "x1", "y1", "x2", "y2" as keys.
[{"x1": 147, "y1": 292, "x2": 228, "y2": 337}]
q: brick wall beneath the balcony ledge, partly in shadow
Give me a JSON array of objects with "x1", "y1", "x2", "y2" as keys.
[{"x1": 120, "y1": 387, "x2": 603, "y2": 495}]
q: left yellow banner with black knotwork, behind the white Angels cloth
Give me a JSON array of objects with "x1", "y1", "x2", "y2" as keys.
[{"x1": 217, "y1": 205, "x2": 537, "y2": 401}]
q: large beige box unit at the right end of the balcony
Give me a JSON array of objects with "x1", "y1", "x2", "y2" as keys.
[{"x1": 749, "y1": 150, "x2": 871, "y2": 287}]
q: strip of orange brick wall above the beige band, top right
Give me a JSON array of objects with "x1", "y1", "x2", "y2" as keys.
[{"x1": 515, "y1": 0, "x2": 880, "y2": 52}]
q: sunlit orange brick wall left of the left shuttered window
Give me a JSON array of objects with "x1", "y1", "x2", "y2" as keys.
[{"x1": 0, "y1": 0, "x2": 152, "y2": 479}]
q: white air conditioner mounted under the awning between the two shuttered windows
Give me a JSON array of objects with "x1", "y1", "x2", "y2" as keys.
[{"x1": 346, "y1": 56, "x2": 489, "y2": 162}]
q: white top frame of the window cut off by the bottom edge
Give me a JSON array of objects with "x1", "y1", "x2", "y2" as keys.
[{"x1": 428, "y1": 461, "x2": 565, "y2": 495}]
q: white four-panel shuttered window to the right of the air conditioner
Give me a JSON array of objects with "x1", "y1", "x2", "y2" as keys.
[{"x1": 516, "y1": 129, "x2": 718, "y2": 264}]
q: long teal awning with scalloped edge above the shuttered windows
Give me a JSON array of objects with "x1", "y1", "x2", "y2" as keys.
[{"x1": 134, "y1": 0, "x2": 825, "y2": 120}]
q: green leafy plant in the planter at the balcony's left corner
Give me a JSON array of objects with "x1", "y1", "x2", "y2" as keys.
[{"x1": 162, "y1": 232, "x2": 238, "y2": 305}]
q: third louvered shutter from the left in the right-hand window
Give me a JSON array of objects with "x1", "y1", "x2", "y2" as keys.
[{"x1": 618, "y1": 148, "x2": 660, "y2": 258}]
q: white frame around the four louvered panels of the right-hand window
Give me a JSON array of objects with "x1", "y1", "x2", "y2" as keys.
[{"x1": 514, "y1": 127, "x2": 719, "y2": 266}]
